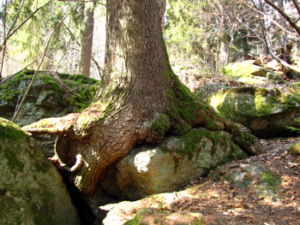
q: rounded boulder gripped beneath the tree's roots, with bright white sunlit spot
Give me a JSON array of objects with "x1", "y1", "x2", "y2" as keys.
[{"x1": 102, "y1": 128, "x2": 247, "y2": 200}]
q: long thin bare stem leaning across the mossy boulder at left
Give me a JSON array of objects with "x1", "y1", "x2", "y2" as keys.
[{"x1": 12, "y1": 5, "x2": 80, "y2": 122}]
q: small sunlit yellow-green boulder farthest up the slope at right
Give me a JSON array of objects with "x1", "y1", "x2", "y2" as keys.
[{"x1": 218, "y1": 60, "x2": 282, "y2": 84}]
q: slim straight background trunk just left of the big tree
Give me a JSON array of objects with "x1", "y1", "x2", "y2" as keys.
[{"x1": 79, "y1": 3, "x2": 95, "y2": 77}]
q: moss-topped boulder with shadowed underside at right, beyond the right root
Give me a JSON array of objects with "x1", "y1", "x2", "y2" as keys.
[{"x1": 208, "y1": 85, "x2": 300, "y2": 138}]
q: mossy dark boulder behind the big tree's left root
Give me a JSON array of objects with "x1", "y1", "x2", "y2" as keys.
[{"x1": 0, "y1": 70, "x2": 99, "y2": 156}]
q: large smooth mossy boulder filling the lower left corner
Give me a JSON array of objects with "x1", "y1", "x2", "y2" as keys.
[{"x1": 0, "y1": 118, "x2": 80, "y2": 225}]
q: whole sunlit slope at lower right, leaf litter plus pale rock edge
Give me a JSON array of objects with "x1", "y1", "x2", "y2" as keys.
[{"x1": 100, "y1": 138, "x2": 300, "y2": 225}]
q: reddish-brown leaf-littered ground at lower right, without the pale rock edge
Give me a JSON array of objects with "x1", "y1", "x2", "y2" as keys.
[{"x1": 179, "y1": 138, "x2": 300, "y2": 225}]
